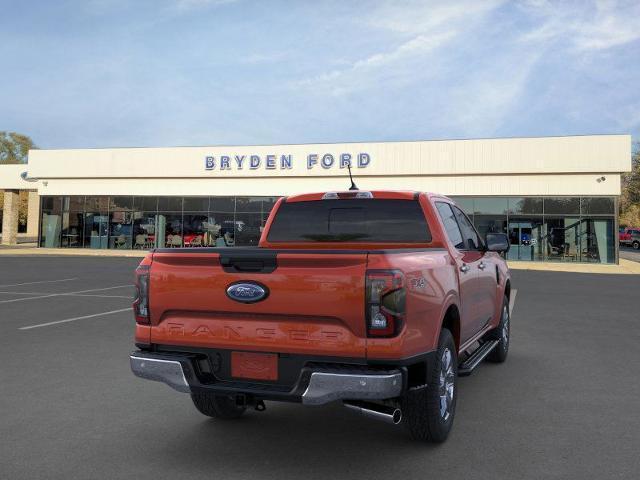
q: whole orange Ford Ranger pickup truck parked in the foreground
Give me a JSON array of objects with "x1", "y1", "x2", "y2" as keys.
[{"x1": 130, "y1": 190, "x2": 511, "y2": 442}]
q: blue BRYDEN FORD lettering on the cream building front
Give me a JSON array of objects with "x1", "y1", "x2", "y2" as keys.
[{"x1": 204, "y1": 153, "x2": 371, "y2": 170}]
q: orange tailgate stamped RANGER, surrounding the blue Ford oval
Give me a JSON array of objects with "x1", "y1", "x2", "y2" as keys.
[{"x1": 149, "y1": 248, "x2": 367, "y2": 357}]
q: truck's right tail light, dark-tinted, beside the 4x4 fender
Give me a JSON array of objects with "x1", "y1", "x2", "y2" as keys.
[{"x1": 366, "y1": 270, "x2": 406, "y2": 337}]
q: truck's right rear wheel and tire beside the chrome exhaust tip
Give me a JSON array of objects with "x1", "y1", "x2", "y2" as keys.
[{"x1": 400, "y1": 328, "x2": 458, "y2": 443}]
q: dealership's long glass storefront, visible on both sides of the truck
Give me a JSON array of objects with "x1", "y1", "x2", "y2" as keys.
[{"x1": 33, "y1": 196, "x2": 617, "y2": 263}]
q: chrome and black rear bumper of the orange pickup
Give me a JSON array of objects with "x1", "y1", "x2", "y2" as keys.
[{"x1": 130, "y1": 351, "x2": 405, "y2": 405}]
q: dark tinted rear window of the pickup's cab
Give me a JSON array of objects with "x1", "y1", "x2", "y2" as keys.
[{"x1": 267, "y1": 199, "x2": 431, "y2": 243}]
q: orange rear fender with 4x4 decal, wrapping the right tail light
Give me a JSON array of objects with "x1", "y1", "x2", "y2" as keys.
[{"x1": 367, "y1": 248, "x2": 458, "y2": 359}]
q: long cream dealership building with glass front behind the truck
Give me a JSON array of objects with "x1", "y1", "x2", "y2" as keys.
[{"x1": 0, "y1": 135, "x2": 631, "y2": 263}]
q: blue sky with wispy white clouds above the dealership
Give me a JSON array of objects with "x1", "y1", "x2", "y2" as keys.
[{"x1": 0, "y1": 0, "x2": 640, "y2": 148}]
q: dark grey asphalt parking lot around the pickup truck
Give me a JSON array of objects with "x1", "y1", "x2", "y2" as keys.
[{"x1": 0, "y1": 256, "x2": 640, "y2": 480}]
